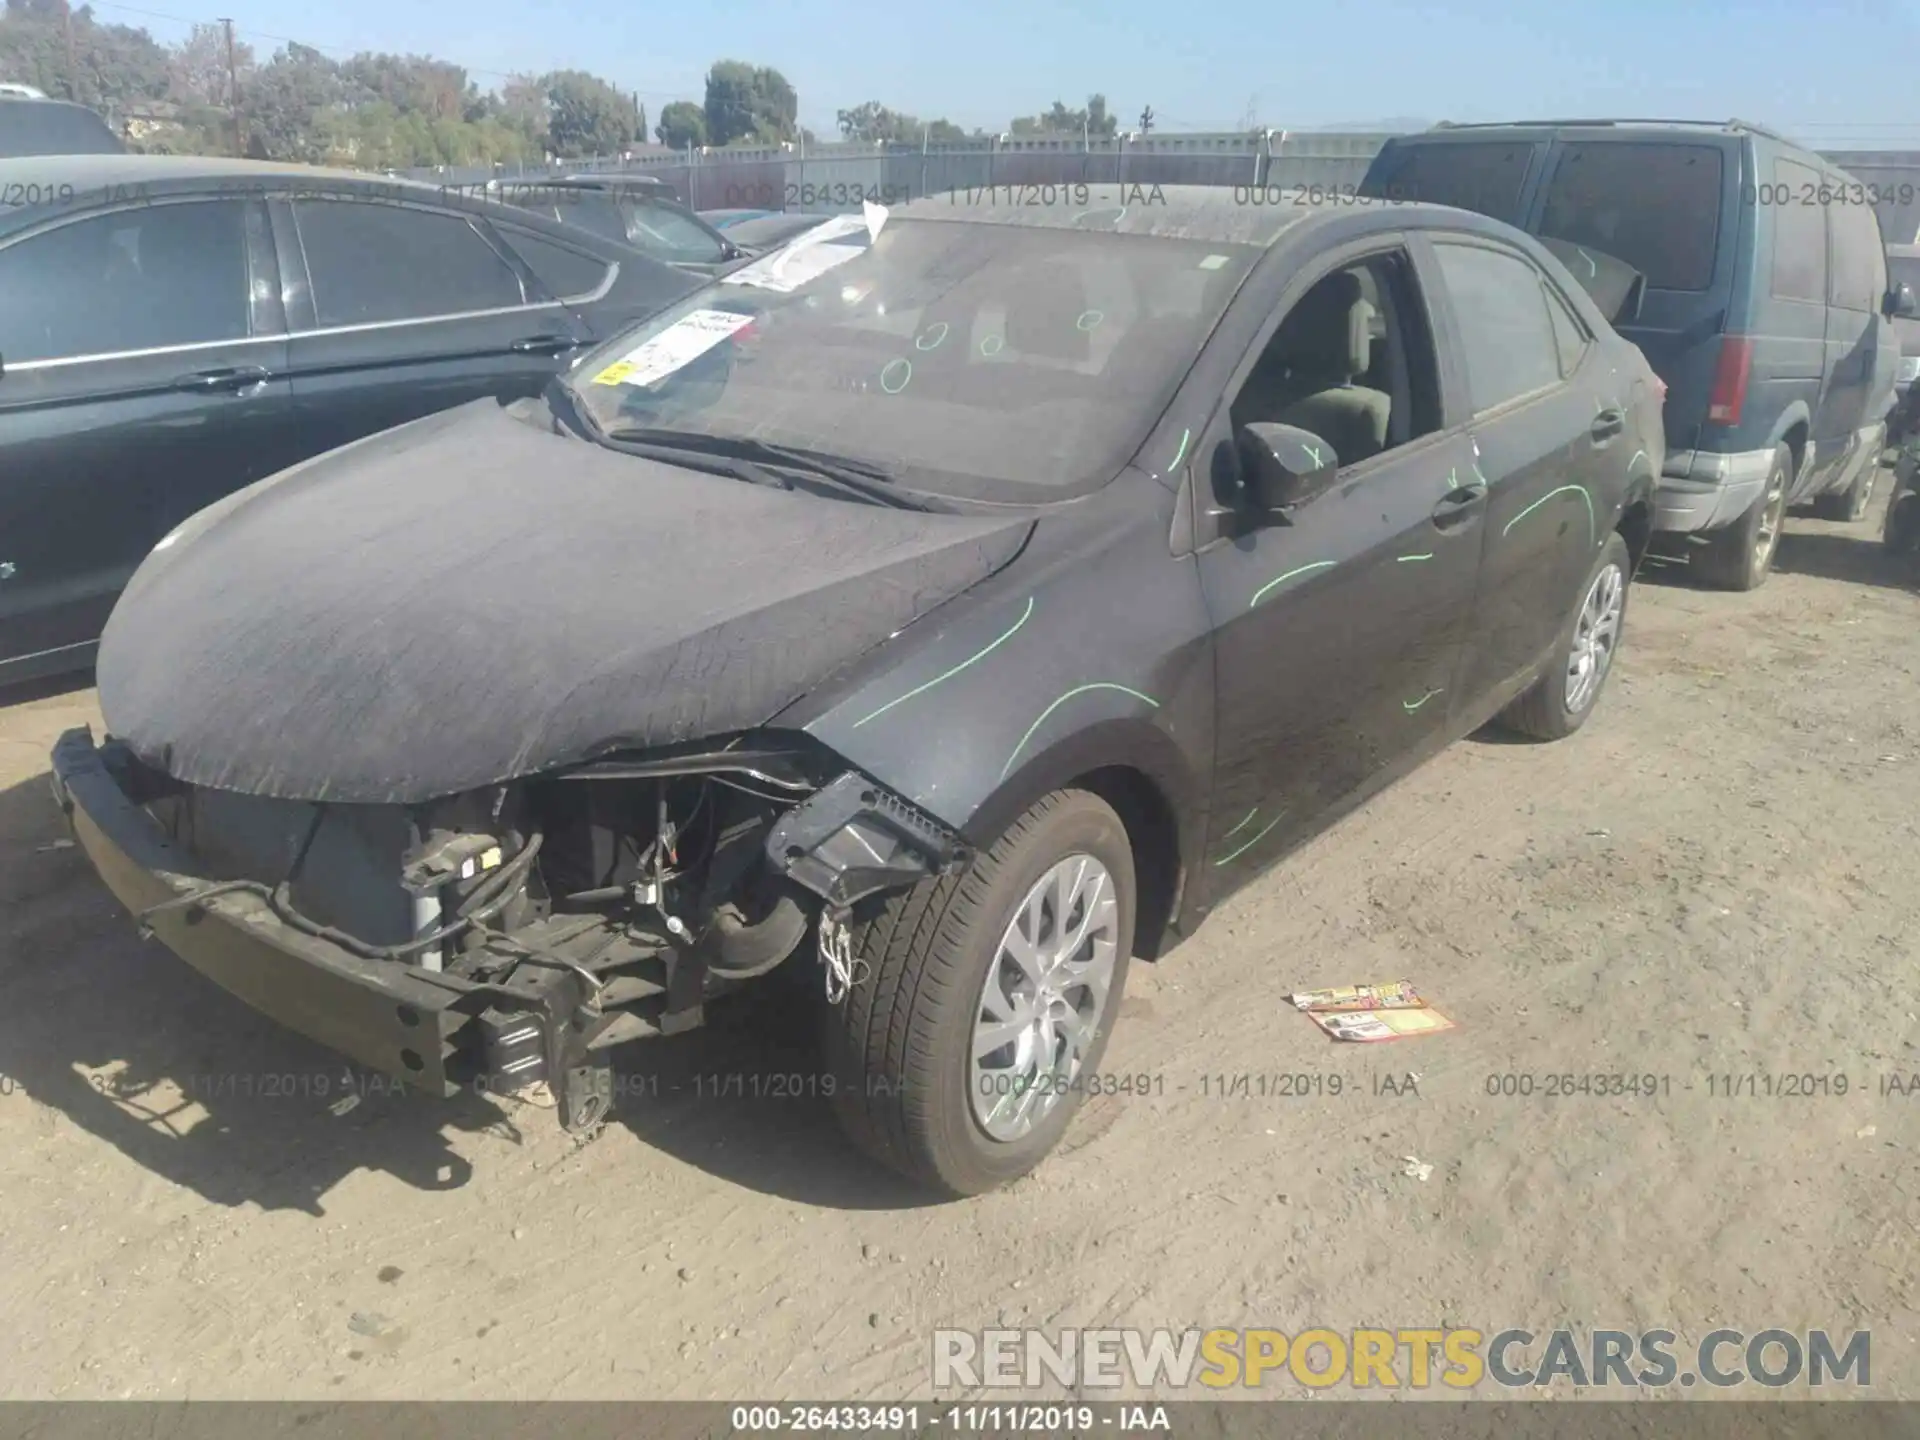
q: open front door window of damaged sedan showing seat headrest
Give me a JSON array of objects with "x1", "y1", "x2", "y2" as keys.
[{"x1": 1229, "y1": 250, "x2": 1440, "y2": 470}]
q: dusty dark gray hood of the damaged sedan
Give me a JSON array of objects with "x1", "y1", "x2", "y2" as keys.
[{"x1": 98, "y1": 401, "x2": 1031, "y2": 803}]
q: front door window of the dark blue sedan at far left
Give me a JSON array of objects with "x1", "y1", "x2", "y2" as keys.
[{"x1": 0, "y1": 200, "x2": 252, "y2": 363}]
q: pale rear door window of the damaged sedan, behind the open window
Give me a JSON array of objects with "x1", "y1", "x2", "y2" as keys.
[{"x1": 1434, "y1": 242, "x2": 1561, "y2": 415}]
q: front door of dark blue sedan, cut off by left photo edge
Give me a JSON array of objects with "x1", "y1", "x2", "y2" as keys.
[{"x1": 0, "y1": 198, "x2": 290, "y2": 684}]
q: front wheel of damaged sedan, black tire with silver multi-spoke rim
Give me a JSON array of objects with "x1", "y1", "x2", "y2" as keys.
[{"x1": 824, "y1": 789, "x2": 1137, "y2": 1196}]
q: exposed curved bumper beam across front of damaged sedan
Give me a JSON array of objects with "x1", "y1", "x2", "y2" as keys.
[{"x1": 52, "y1": 728, "x2": 625, "y2": 1127}]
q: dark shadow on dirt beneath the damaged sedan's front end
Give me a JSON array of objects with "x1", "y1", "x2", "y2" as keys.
[{"x1": 0, "y1": 774, "x2": 925, "y2": 1215}]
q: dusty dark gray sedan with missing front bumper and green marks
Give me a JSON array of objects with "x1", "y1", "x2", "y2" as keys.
[{"x1": 54, "y1": 186, "x2": 1659, "y2": 1194}]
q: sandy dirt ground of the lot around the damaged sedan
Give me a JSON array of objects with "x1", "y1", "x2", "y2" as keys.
[{"x1": 0, "y1": 495, "x2": 1920, "y2": 1400}]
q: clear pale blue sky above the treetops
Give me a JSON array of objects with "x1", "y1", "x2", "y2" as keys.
[{"x1": 94, "y1": 0, "x2": 1920, "y2": 148}]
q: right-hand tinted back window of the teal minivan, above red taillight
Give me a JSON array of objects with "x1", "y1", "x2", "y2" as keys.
[{"x1": 1540, "y1": 140, "x2": 1724, "y2": 290}]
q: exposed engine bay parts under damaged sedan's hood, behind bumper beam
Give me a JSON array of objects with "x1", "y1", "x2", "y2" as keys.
[{"x1": 109, "y1": 735, "x2": 964, "y2": 1131}]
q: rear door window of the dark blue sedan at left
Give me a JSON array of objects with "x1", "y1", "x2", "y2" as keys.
[{"x1": 294, "y1": 200, "x2": 524, "y2": 326}]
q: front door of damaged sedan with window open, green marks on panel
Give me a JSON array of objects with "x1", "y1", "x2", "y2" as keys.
[{"x1": 1196, "y1": 240, "x2": 1484, "y2": 893}]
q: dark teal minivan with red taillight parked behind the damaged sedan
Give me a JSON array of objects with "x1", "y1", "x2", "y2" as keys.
[{"x1": 1361, "y1": 119, "x2": 1910, "y2": 589}]
